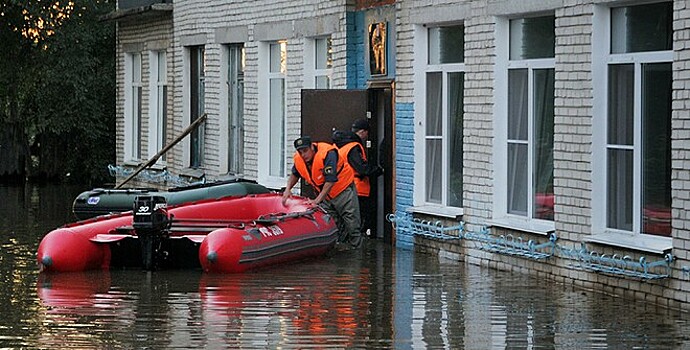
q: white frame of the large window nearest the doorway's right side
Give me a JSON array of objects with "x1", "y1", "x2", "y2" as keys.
[{"x1": 408, "y1": 25, "x2": 465, "y2": 218}]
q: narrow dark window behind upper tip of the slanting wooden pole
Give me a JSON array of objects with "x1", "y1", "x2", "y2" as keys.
[{"x1": 189, "y1": 46, "x2": 206, "y2": 168}]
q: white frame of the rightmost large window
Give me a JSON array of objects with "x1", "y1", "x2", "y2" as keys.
[{"x1": 586, "y1": 5, "x2": 673, "y2": 253}]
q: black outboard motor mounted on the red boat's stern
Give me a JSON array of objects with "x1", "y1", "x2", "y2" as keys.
[{"x1": 132, "y1": 196, "x2": 171, "y2": 271}]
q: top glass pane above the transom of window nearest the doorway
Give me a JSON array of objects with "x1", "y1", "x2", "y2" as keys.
[{"x1": 429, "y1": 25, "x2": 465, "y2": 64}]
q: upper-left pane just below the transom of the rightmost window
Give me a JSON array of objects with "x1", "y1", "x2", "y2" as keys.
[{"x1": 607, "y1": 64, "x2": 635, "y2": 145}]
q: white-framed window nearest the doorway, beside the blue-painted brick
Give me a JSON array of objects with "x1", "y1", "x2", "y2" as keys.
[{"x1": 424, "y1": 25, "x2": 465, "y2": 207}]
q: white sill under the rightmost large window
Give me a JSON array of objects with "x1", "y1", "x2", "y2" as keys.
[{"x1": 584, "y1": 232, "x2": 673, "y2": 254}]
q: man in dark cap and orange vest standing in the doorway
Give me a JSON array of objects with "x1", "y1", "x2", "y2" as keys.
[{"x1": 333, "y1": 119, "x2": 383, "y2": 237}]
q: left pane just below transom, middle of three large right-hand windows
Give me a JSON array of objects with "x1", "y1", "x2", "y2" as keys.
[{"x1": 508, "y1": 69, "x2": 529, "y2": 140}]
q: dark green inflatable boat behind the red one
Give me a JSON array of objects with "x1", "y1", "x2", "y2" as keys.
[{"x1": 72, "y1": 179, "x2": 270, "y2": 220}]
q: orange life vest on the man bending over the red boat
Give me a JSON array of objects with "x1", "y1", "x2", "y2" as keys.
[{"x1": 292, "y1": 142, "x2": 355, "y2": 199}]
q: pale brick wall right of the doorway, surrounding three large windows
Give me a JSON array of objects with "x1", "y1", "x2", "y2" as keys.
[{"x1": 396, "y1": 0, "x2": 690, "y2": 307}]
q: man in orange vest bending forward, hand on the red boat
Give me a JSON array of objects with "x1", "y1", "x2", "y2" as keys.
[{"x1": 283, "y1": 136, "x2": 362, "y2": 248}]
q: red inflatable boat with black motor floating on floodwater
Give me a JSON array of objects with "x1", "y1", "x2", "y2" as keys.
[{"x1": 37, "y1": 193, "x2": 338, "y2": 272}]
